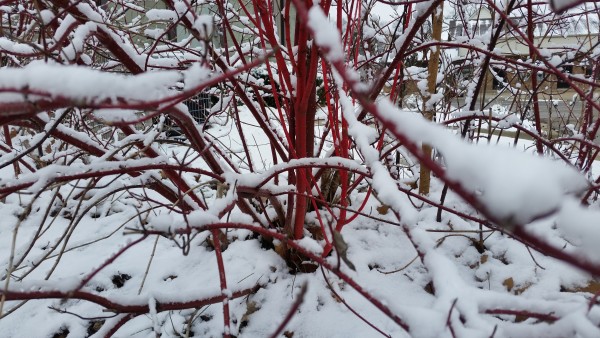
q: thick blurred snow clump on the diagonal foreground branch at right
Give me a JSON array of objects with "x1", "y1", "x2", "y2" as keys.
[{"x1": 378, "y1": 100, "x2": 588, "y2": 228}]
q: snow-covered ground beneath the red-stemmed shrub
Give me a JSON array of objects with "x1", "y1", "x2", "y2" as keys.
[{"x1": 0, "y1": 104, "x2": 600, "y2": 337}]
